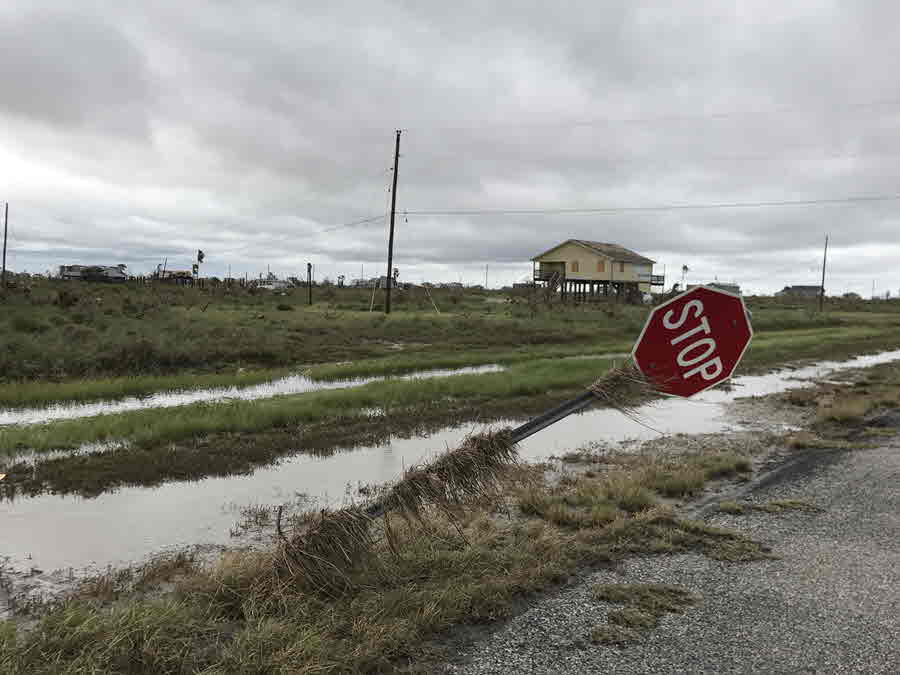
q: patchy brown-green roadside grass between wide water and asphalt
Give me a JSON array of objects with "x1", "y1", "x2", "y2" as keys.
[{"x1": 0, "y1": 430, "x2": 770, "y2": 673}]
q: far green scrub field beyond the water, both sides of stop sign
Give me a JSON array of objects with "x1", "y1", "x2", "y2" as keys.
[{"x1": 0, "y1": 280, "x2": 900, "y2": 407}]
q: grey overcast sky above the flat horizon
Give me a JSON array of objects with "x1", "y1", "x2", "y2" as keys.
[{"x1": 0, "y1": 0, "x2": 900, "y2": 295}]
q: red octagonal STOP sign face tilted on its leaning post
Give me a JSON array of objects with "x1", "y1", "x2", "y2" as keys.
[{"x1": 632, "y1": 286, "x2": 753, "y2": 397}]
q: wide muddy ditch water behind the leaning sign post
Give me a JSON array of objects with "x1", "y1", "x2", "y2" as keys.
[{"x1": 0, "y1": 350, "x2": 900, "y2": 588}]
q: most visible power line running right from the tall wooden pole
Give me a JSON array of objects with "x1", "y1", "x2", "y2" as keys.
[{"x1": 405, "y1": 194, "x2": 900, "y2": 216}]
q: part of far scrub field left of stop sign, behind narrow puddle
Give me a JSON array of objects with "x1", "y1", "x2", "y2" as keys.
[{"x1": 0, "y1": 281, "x2": 647, "y2": 385}]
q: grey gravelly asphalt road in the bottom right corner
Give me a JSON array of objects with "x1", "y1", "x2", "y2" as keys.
[{"x1": 444, "y1": 438, "x2": 900, "y2": 674}]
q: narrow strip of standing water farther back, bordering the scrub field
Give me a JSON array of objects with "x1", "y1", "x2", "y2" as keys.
[{"x1": 0, "y1": 364, "x2": 505, "y2": 426}]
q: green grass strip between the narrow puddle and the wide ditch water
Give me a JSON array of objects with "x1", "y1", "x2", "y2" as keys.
[{"x1": 7, "y1": 316, "x2": 900, "y2": 454}]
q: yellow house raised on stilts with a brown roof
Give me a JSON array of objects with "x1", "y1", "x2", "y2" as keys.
[{"x1": 531, "y1": 239, "x2": 665, "y2": 300}]
